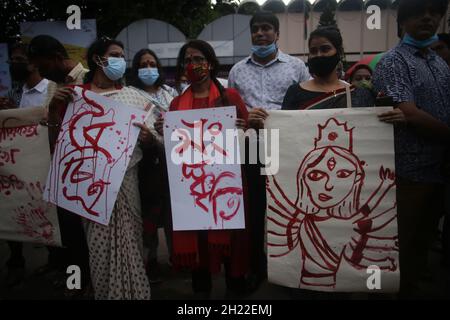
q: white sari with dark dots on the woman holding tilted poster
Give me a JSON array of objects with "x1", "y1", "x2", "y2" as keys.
[{"x1": 85, "y1": 87, "x2": 155, "y2": 300}]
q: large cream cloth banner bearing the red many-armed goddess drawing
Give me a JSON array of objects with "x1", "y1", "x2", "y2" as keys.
[{"x1": 266, "y1": 108, "x2": 399, "y2": 292}]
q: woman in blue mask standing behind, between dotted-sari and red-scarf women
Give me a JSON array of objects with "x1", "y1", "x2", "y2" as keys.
[{"x1": 131, "y1": 49, "x2": 178, "y2": 283}]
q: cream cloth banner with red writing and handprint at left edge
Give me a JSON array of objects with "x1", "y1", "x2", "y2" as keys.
[{"x1": 0, "y1": 108, "x2": 61, "y2": 246}]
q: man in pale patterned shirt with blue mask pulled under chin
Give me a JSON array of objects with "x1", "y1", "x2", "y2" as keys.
[{"x1": 228, "y1": 12, "x2": 310, "y2": 291}]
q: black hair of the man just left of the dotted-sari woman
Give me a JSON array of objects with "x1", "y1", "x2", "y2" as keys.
[{"x1": 28, "y1": 35, "x2": 69, "y2": 59}]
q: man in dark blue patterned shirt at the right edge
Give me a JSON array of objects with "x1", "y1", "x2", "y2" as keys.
[{"x1": 374, "y1": 0, "x2": 450, "y2": 297}]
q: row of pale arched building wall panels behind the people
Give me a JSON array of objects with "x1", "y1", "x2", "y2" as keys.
[{"x1": 117, "y1": 6, "x2": 450, "y2": 66}]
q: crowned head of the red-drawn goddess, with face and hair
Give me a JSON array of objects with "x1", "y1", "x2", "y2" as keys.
[{"x1": 296, "y1": 120, "x2": 365, "y2": 218}]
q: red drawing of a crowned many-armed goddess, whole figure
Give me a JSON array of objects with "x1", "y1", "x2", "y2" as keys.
[{"x1": 267, "y1": 118, "x2": 398, "y2": 290}]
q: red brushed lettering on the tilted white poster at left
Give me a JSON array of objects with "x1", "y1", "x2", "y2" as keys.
[{"x1": 49, "y1": 90, "x2": 136, "y2": 217}]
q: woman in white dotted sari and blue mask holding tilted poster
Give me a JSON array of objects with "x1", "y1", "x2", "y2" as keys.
[{"x1": 48, "y1": 38, "x2": 155, "y2": 300}]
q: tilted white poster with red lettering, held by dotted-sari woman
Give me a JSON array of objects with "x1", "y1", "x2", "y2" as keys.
[{"x1": 44, "y1": 87, "x2": 147, "y2": 225}]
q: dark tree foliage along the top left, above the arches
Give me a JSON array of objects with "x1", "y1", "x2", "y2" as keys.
[{"x1": 0, "y1": 0, "x2": 243, "y2": 42}]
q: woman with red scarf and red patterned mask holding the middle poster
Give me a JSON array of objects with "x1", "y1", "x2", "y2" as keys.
[{"x1": 155, "y1": 40, "x2": 250, "y2": 298}]
